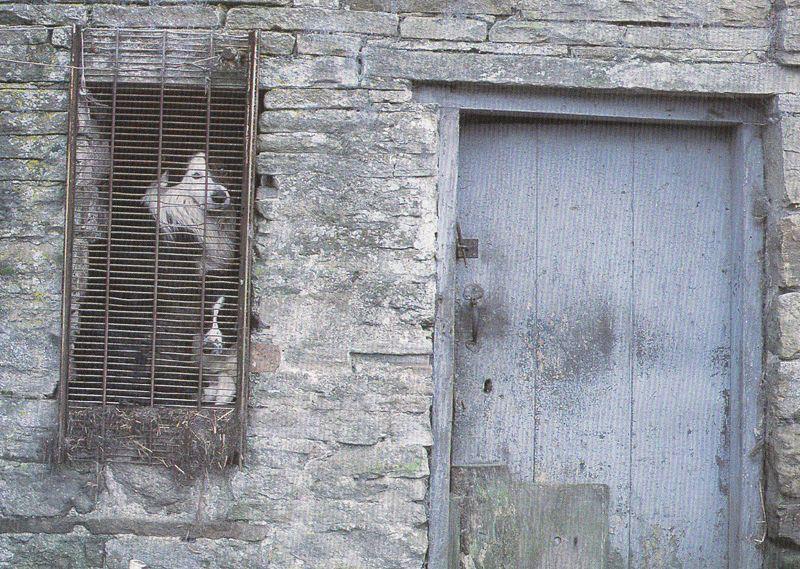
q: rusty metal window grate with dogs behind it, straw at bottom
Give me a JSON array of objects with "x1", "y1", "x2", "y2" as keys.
[{"x1": 57, "y1": 29, "x2": 258, "y2": 471}]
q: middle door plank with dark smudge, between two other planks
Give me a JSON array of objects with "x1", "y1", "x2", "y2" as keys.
[{"x1": 526, "y1": 118, "x2": 633, "y2": 566}]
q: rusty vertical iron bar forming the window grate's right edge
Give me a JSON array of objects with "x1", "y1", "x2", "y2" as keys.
[{"x1": 236, "y1": 30, "x2": 260, "y2": 466}]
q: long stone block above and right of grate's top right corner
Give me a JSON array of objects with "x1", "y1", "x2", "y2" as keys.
[{"x1": 225, "y1": 7, "x2": 398, "y2": 36}]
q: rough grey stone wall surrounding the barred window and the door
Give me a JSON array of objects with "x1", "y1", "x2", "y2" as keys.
[{"x1": 0, "y1": 0, "x2": 800, "y2": 569}]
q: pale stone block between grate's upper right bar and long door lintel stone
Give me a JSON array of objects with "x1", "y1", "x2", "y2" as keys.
[{"x1": 259, "y1": 56, "x2": 358, "y2": 88}]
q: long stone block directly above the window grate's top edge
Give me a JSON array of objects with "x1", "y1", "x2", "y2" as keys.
[{"x1": 92, "y1": 5, "x2": 222, "y2": 29}]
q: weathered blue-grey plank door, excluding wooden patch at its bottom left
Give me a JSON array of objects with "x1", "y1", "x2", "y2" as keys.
[{"x1": 452, "y1": 118, "x2": 748, "y2": 569}]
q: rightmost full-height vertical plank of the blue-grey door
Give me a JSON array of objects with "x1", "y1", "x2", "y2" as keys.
[{"x1": 631, "y1": 126, "x2": 732, "y2": 569}]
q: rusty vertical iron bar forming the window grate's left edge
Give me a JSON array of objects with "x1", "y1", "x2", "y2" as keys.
[{"x1": 54, "y1": 26, "x2": 83, "y2": 463}]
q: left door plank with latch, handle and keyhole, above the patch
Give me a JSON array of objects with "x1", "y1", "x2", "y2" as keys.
[{"x1": 453, "y1": 120, "x2": 536, "y2": 474}]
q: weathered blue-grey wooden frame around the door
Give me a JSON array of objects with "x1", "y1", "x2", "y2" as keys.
[{"x1": 424, "y1": 85, "x2": 766, "y2": 569}]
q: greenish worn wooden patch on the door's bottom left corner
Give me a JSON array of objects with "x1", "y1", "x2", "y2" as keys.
[{"x1": 450, "y1": 466, "x2": 609, "y2": 569}]
